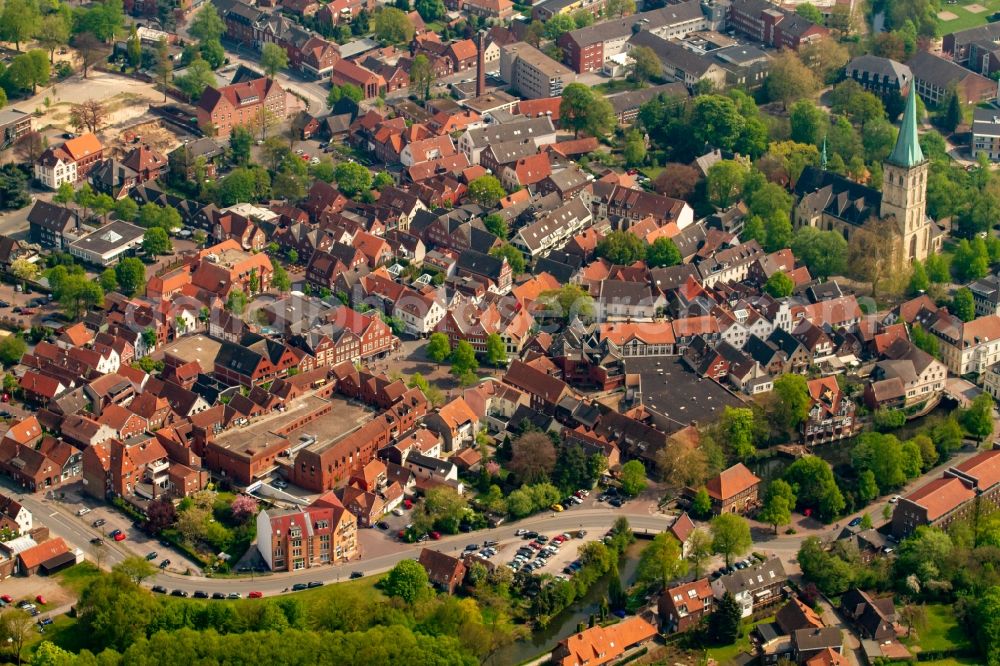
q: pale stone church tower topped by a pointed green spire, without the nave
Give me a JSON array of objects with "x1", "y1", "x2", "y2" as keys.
[{"x1": 881, "y1": 85, "x2": 931, "y2": 264}]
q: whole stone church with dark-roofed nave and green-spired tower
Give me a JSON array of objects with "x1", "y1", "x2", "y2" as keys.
[{"x1": 793, "y1": 87, "x2": 944, "y2": 267}]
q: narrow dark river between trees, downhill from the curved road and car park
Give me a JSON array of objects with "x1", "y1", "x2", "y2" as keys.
[{"x1": 484, "y1": 539, "x2": 649, "y2": 666}]
